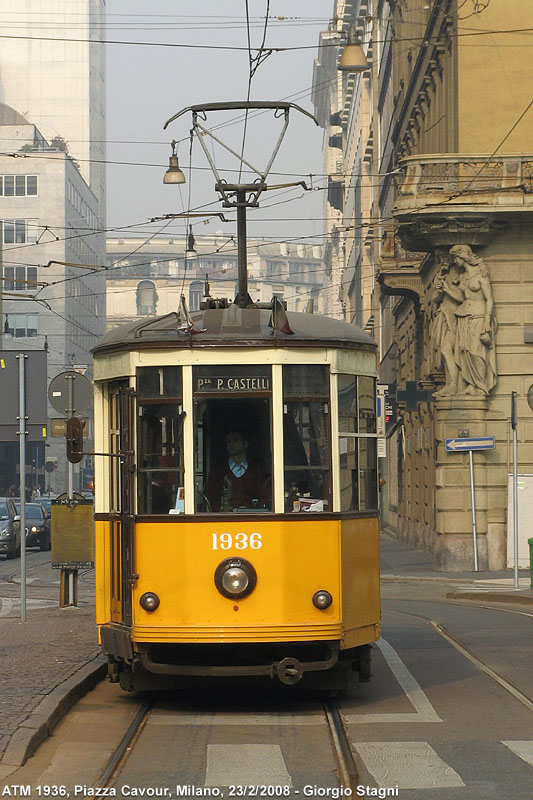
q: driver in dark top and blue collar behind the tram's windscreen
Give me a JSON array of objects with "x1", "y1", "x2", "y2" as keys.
[{"x1": 207, "y1": 430, "x2": 269, "y2": 511}]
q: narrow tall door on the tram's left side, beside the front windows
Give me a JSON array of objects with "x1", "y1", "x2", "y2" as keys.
[{"x1": 109, "y1": 381, "x2": 135, "y2": 625}]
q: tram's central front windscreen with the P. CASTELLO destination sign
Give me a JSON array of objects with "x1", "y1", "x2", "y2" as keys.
[{"x1": 193, "y1": 364, "x2": 273, "y2": 514}]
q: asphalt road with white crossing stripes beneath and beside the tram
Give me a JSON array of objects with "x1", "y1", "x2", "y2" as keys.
[{"x1": 4, "y1": 564, "x2": 533, "y2": 800}]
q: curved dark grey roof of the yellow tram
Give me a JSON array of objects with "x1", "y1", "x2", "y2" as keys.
[{"x1": 92, "y1": 305, "x2": 376, "y2": 355}]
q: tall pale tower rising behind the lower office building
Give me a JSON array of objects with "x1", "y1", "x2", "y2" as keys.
[{"x1": 0, "y1": 0, "x2": 105, "y2": 219}]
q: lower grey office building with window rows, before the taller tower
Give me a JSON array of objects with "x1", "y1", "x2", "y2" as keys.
[{"x1": 0, "y1": 104, "x2": 105, "y2": 491}]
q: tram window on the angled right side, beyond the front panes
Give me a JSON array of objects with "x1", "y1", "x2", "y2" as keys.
[{"x1": 337, "y1": 375, "x2": 378, "y2": 511}]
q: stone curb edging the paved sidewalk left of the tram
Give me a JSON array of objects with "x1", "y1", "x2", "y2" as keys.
[{"x1": 0, "y1": 655, "x2": 107, "y2": 767}]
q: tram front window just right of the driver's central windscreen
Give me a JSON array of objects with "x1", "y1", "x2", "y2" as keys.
[{"x1": 283, "y1": 364, "x2": 331, "y2": 512}]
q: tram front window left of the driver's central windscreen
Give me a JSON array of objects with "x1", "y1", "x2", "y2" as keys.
[{"x1": 137, "y1": 367, "x2": 184, "y2": 514}]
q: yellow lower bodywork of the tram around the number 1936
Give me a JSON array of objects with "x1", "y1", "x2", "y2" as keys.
[{"x1": 96, "y1": 517, "x2": 380, "y2": 648}]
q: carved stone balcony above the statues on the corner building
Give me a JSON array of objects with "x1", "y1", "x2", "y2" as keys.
[{"x1": 393, "y1": 153, "x2": 533, "y2": 251}]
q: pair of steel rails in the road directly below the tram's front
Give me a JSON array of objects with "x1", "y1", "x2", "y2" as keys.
[{"x1": 94, "y1": 698, "x2": 359, "y2": 796}]
